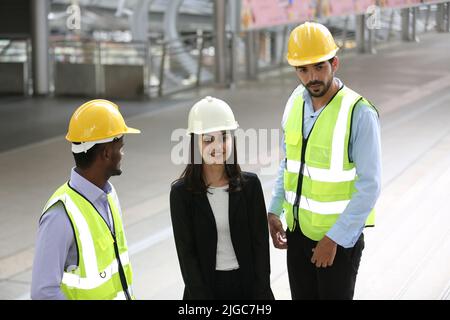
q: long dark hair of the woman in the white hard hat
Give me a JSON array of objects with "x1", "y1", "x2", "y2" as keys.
[{"x1": 173, "y1": 133, "x2": 245, "y2": 193}]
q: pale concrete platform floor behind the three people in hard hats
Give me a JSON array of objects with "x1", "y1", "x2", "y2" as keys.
[{"x1": 0, "y1": 34, "x2": 450, "y2": 299}]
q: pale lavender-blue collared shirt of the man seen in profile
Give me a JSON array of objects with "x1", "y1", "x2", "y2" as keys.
[{"x1": 31, "y1": 168, "x2": 120, "y2": 300}]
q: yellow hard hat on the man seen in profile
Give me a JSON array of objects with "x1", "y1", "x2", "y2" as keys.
[{"x1": 66, "y1": 99, "x2": 141, "y2": 143}]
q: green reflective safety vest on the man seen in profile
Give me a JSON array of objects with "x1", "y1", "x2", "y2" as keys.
[{"x1": 43, "y1": 183, "x2": 134, "y2": 300}]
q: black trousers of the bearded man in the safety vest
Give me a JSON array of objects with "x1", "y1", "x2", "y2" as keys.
[{"x1": 286, "y1": 224, "x2": 364, "y2": 300}]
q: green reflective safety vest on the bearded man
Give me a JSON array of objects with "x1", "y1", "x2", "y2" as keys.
[{"x1": 283, "y1": 86, "x2": 376, "y2": 241}]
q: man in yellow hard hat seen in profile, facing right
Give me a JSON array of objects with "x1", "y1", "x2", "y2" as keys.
[{"x1": 31, "y1": 99, "x2": 140, "y2": 300}]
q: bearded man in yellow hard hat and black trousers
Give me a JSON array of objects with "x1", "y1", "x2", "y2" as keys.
[{"x1": 268, "y1": 22, "x2": 381, "y2": 299}]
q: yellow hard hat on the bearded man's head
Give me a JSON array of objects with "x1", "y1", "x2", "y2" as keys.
[{"x1": 286, "y1": 22, "x2": 339, "y2": 67}]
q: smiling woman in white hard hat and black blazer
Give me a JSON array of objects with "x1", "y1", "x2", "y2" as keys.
[{"x1": 170, "y1": 97, "x2": 273, "y2": 300}]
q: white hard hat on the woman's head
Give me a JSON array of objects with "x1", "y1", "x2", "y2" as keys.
[{"x1": 187, "y1": 96, "x2": 239, "y2": 134}]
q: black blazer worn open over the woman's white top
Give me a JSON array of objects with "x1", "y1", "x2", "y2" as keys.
[{"x1": 170, "y1": 172, "x2": 273, "y2": 299}]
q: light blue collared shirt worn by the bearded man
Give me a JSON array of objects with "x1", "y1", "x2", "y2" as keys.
[{"x1": 269, "y1": 78, "x2": 381, "y2": 248}]
